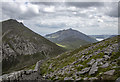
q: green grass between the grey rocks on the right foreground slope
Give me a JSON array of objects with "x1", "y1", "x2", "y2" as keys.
[{"x1": 40, "y1": 36, "x2": 120, "y2": 80}]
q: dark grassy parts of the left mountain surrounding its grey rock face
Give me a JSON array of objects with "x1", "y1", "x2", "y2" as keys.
[{"x1": 2, "y1": 20, "x2": 64, "y2": 73}]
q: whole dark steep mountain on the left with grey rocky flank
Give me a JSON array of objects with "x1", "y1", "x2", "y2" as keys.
[{"x1": 1, "y1": 19, "x2": 65, "y2": 73}]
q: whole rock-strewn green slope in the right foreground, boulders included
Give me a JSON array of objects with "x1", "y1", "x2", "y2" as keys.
[{"x1": 40, "y1": 36, "x2": 120, "y2": 82}]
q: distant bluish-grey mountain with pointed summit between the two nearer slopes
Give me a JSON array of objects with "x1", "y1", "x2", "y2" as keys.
[{"x1": 45, "y1": 28, "x2": 97, "y2": 49}]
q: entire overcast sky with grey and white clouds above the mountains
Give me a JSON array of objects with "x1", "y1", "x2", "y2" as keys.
[{"x1": 0, "y1": 0, "x2": 119, "y2": 35}]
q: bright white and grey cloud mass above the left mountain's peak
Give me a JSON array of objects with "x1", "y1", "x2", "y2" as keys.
[{"x1": 2, "y1": 2, "x2": 39, "y2": 19}]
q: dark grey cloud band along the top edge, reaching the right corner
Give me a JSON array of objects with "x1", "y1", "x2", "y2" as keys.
[{"x1": 32, "y1": 2, "x2": 120, "y2": 17}]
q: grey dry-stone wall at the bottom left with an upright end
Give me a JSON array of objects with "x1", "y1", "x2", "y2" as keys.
[{"x1": 1, "y1": 61, "x2": 42, "y2": 82}]
